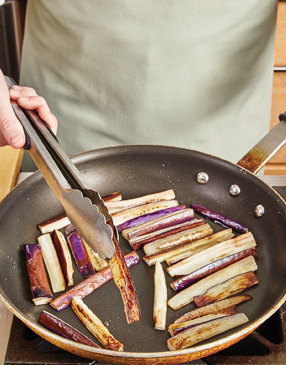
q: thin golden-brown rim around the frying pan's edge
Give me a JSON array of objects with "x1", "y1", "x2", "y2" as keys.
[{"x1": 0, "y1": 145, "x2": 286, "y2": 360}]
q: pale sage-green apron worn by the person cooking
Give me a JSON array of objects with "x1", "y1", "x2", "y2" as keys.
[{"x1": 21, "y1": 0, "x2": 277, "y2": 168}]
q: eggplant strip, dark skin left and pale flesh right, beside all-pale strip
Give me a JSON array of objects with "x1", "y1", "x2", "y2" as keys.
[{"x1": 52, "y1": 230, "x2": 74, "y2": 286}]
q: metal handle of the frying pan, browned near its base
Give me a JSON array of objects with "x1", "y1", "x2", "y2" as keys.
[{"x1": 237, "y1": 112, "x2": 286, "y2": 175}]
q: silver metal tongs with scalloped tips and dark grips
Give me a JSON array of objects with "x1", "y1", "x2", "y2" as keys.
[{"x1": 5, "y1": 76, "x2": 115, "y2": 258}]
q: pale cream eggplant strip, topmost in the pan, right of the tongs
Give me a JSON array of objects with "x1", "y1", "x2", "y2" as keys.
[{"x1": 105, "y1": 189, "x2": 175, "y2": 214}]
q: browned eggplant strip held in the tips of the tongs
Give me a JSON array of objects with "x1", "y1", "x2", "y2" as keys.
[{"x1": 109, "y1": 240, "x2": 141, "y2": 323}]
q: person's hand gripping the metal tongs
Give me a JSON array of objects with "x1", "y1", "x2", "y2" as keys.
[{"x1": 0, "y1": 70, "x2": 58, "y2": 148}]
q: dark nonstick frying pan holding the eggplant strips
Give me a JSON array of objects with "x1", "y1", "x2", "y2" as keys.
[{"x1": 0, "y1": 123, "x2": 286, "y2": 364}]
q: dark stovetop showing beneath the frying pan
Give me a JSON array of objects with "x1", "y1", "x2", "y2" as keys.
[{"x1": 4, "y1": 187, "x2": 286, "y2": 365}]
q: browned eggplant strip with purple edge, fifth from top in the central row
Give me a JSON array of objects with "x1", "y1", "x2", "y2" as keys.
[{"x1": 129, "y1": 219, "x2": 204, "y2": 250}]
